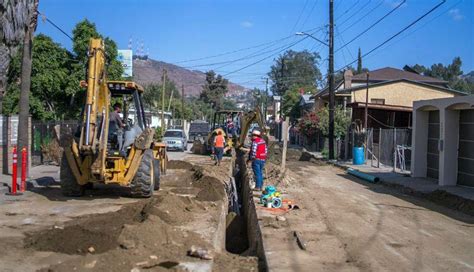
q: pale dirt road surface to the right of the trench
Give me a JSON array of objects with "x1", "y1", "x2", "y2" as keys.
[{"x1": 264, "y1": 162, "x2": 474, "y2": 271}]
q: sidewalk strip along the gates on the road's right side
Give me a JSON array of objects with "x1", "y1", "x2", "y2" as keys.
[{"x1": 306, "y1": 151, "x2": 474, "y2": 215}]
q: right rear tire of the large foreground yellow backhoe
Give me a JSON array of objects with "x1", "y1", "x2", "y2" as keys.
[{"x1": 130, "y1": 150, "x2": 154, "y2": 197}]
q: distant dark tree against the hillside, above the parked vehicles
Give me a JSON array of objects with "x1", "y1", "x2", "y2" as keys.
[{"x1": 200, "y1": 70, "x2": 229, "y2": 110}]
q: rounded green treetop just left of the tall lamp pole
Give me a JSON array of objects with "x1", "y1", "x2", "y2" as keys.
[{"x1": 268, "y1": 50, "x2": 321, "y2": 95}]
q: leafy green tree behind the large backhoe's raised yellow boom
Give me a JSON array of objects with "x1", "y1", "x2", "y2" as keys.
[{"x1": 3, "y1": 20, "x2": 123, "y2": 120}]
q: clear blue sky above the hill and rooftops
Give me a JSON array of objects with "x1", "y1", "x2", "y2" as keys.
[{"x1": 37, "y1": 0, "x2": 474, "y2": 87}]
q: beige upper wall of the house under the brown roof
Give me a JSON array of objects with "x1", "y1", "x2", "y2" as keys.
[{"x1": 352, "y1": 82, "x2": 455, "y2": 107}]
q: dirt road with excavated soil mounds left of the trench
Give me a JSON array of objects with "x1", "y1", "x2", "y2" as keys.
[{"x1": 0, "y1": 153, "x2": 258, "y2": 272}]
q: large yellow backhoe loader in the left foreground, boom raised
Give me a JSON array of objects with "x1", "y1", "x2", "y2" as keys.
[{"x1": 60, "y1": 39, "x2": 167, "y2": 197}]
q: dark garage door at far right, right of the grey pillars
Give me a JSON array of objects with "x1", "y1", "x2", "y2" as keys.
[{"x1": 458, "y1": 110, "x2": 474, "y2": 187}]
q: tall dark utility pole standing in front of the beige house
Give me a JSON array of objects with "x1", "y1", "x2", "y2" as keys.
[{"x1": 329, "y1": 0, "x2": 334, "y2": 160}]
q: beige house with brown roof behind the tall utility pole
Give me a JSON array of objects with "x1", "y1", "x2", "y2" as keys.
[{"x1": 313, "y1": 67, "x2": 465, "y2": 128}]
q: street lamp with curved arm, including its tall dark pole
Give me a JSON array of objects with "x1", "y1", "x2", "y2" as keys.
[{"x1": 295, "y1": 28, "x2": 335, "y2": 160}]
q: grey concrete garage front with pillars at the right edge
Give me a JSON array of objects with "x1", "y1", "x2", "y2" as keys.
[{"x1": 411, "y1": 95, "x2": 474, "y2": 187}]
